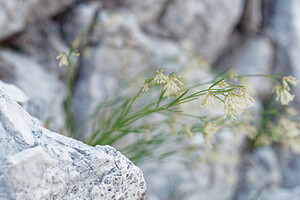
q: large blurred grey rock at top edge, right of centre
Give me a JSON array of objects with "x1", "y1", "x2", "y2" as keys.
[{"x1": 161, "y1": 0, "x2": 244, "y2": 62}]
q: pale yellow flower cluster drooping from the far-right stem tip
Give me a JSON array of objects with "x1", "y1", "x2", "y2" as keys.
[{"x1": 272, "y1": 76, "x2": 298, "y2": 105}]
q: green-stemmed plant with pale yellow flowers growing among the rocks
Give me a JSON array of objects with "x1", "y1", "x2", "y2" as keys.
[{"x1": 57, "y1": 45, "x2": 300, "y2": 162}]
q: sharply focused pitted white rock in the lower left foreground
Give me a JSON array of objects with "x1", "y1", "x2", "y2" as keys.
[{"x1": 0, "y1": 89, "x2": 146, "y2": 200}]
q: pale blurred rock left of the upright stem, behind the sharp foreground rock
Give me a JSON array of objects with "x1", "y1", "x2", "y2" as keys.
[{"x1": 0, "y1": 49, "x2": 66, "y2": 131}]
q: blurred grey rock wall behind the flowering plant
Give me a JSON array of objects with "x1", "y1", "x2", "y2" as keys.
[{"x1": 0, "y1": 0, "x2": 300, "y2": 200}]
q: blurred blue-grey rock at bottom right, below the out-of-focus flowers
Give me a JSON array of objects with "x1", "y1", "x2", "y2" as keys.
[{"x1": 233, "y1": 147, "x2": 300, "y2": 200}]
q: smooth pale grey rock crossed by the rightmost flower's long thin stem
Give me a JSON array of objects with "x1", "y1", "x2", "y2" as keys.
[{"x1": 219, "y1": 36, "x2": 274, "y2": 99}]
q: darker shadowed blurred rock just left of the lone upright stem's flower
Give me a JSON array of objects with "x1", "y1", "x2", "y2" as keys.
[{"x1": 13, "y1": 20, "x2": 71, "y2": 80}]
